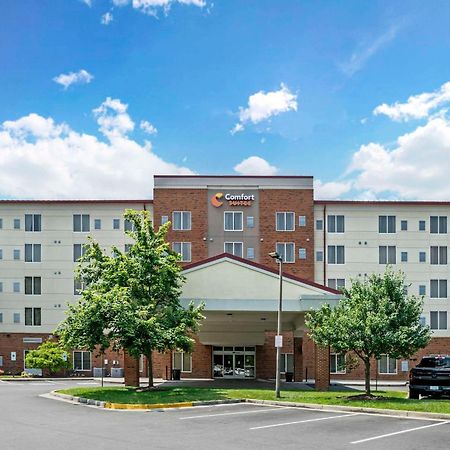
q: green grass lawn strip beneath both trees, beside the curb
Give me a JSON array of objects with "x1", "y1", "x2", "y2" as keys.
[{"x1": 58, "y1": 387, "x2": 450, "y2": 414}]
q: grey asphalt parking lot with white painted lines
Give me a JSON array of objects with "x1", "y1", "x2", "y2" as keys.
[{"x1": 0, "y1": 380, "x2": 450, "y2": 450}]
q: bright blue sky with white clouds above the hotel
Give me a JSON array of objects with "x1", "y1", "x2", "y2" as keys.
[{"x1": 0, "y1": 0, "x2": 450, "y2": 200}]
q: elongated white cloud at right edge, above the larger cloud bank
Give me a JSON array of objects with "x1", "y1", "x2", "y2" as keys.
[{"x1": 373, "y1": 82, "x2": 450, "y2": 122}]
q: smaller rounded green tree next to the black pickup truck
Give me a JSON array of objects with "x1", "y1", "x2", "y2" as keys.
[{"x1": 306, "y1": 268, "x2": 431, "y2": 396}]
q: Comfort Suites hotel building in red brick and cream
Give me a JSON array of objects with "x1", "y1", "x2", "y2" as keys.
[{"x1": 0, "y1": 176, "x2": 450, "y2": 383}]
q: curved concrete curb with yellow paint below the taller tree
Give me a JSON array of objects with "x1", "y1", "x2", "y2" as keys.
[{"x1": 50, "y1": 391, "x2": 244, "y2": 410}]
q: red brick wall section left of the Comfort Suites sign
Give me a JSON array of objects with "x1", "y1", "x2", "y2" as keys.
[{"x1": 153, "y1": 188, "x2": 208, "y2": 262}]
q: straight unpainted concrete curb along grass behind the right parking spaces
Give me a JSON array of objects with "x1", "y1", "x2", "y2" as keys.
[{"x1": 242, "y1": 399, "x2": 450, "y2": 420}]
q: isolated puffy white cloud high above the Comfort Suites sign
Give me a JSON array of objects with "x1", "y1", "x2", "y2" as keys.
[{"x1": 231, "y1": 83, "x2": 297, "y2": 134}]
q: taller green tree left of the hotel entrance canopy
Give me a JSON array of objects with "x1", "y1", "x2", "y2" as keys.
[{"x1": 55, "y1": 210, "x2": 203, "y2": 387}]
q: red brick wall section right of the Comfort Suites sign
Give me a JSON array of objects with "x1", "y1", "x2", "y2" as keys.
[{"x1": 259, "y1": 189, "x2": 314, "y2": 281}]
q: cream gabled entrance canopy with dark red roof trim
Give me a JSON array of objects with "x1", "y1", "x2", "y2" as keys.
[{"x1": 180, "y1": 253, "x2": 340, "y2": 346}]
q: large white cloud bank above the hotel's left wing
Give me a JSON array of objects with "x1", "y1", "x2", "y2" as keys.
[{"x1": 0, "y1": 99, "x2": 193, "y2": 199}]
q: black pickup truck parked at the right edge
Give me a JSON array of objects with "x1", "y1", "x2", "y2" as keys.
[{"x1": 409, "y1": 355, "x2": 450, "y2": 399}]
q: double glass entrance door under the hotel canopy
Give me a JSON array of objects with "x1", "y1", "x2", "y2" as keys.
[{"x1": 213, "y1": 347, "x2": 255, "y2": 378}]
